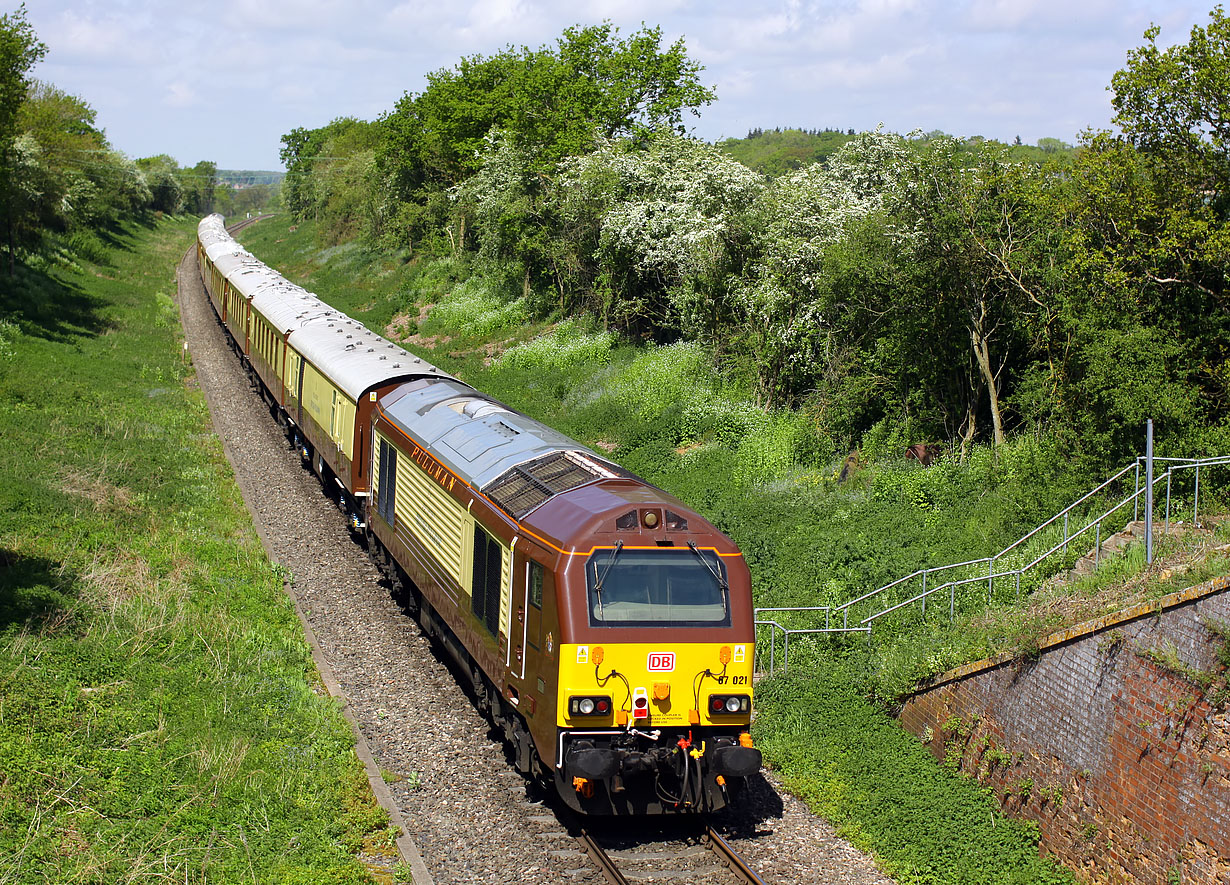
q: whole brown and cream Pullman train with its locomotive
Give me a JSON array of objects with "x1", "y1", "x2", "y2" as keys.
[{"x1": 197, "y1": 215, "x2": 761, "y2": 816}]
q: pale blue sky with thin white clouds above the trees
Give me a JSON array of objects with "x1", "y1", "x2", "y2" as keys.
[{"x1": 23, "y1": 0, "x2": 1213, "y2": 170}]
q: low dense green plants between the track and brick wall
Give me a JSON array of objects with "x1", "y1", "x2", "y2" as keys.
[{"x1": 755, "y1": 665, "x2": 1074, "y2": 885}]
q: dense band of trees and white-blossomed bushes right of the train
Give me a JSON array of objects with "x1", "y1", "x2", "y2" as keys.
[{"x1": 274, "y1": 7, "x2": 1230, "y2": 470}]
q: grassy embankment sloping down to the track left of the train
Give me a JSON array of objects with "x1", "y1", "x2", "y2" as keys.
[{"x1": 0, "y1": 219, "x2": 386, "y2": 884}]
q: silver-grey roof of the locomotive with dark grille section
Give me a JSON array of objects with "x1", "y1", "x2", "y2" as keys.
[{"x1": 381, "y1": 379, "x2": 631, "y2": 519}]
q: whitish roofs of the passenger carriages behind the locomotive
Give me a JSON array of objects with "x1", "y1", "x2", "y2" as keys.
[{"x1": 197, "y1": 215, "x2": 453, "y2": 401}]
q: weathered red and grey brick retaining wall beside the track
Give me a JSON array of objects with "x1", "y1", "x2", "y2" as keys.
[{"x1": 900, "y1": 579, "x2": 1230, "y2": 885}]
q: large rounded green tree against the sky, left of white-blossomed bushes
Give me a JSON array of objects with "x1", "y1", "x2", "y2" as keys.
[{"x1": 376, "y1": 22, "x2": 713, "y2": 251}]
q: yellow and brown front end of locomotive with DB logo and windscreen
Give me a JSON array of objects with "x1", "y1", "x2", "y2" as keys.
[{"x1": 554, "y1": 536, "x2": 760, "y2": 814}]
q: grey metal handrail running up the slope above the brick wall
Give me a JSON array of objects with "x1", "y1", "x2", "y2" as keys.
[{"x1": 755, "y1": 456, "x2": 1230, "y2": 672}]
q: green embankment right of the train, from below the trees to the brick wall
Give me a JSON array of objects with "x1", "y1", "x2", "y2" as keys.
[{"x1": 231, "y1": 219, "x2": 1151, "y2": 885}]
